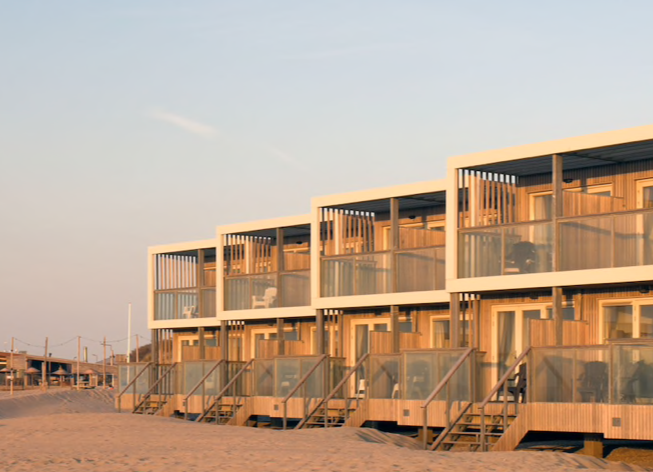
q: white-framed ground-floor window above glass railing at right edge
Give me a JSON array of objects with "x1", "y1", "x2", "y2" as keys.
[{"x1": 601, "y1": 298, "x2": 653, "y2": 341}]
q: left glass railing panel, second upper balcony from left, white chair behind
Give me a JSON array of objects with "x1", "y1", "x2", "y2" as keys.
[{"x1": 224, "y1": 273, "x2": 278, "y2": 310}]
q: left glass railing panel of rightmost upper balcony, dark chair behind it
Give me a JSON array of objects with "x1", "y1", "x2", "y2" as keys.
[{"x1": 458, "y1": 222, "x2": 553, "y2": 278}]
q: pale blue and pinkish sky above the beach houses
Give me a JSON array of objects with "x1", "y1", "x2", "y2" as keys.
[{"x1": 0, "y1": 0, "x2": 653, "y2": 355}]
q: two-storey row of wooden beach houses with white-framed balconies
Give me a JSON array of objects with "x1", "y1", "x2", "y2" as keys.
[{"x1": 117, "y1": 126, "x2": 653, "y2": 451}]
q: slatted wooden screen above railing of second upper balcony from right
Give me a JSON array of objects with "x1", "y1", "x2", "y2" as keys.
[{"x1": 319, "y1": 208, "x2": 376, "y2": 256}]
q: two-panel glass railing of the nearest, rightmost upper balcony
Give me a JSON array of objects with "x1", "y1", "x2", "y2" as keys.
[{"x1": 458, "y1": 209, "x2": 653, "y2": 278}]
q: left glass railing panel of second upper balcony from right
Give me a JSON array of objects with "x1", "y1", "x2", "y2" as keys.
[{"x1": 321, "y1": 252, "x2": 391, "y2": 297}]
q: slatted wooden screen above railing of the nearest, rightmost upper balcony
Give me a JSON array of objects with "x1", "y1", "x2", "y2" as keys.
[{"x1": 458, "y1": 169, "x2": 517, "y2": 228}]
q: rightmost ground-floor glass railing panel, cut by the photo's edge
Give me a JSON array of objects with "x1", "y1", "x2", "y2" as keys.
[{"x1": 612, "y1": 344, "x2": 653, "y2": 405}]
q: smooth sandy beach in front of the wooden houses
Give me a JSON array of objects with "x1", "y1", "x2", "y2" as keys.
[{"x1": 0, "y1": 391, "x2": 644, "y2": 472}]
